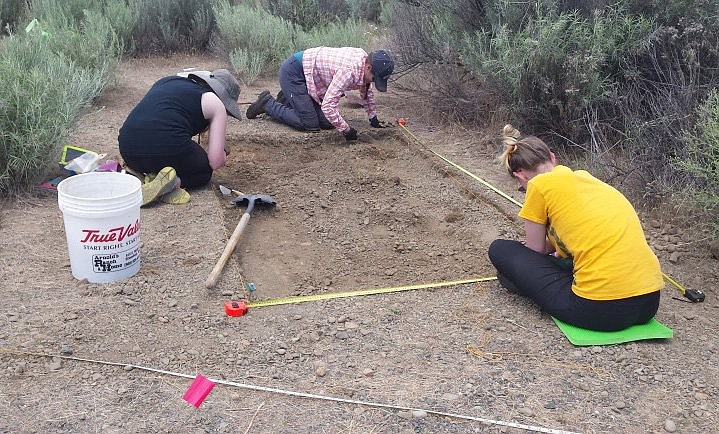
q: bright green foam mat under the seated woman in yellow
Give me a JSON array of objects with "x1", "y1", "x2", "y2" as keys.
[{"x1": 552, "y1": 317, "x2": 674, "y2": 347}]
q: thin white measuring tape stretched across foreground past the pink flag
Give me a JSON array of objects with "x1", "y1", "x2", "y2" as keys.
[{"x1": 0, "y1": 348, "x2": 579, "y2": 434}]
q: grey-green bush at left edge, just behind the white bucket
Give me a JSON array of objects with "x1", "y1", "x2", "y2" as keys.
[{"x1": 0, "y1": 34, "x2": 105, "y2": 196}]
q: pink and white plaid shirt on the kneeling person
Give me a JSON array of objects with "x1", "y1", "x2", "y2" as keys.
[{"x1": 302, "y1": 47, "x2": 377, "y2": 131}]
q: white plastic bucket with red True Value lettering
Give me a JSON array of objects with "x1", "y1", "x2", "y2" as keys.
[{"x1": 57, "y1": 172, "x2": 142, "y2": 283}]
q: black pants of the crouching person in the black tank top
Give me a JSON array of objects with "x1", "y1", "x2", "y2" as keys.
[{"x1": 120, "y1": 140, "x2": 212, "y2": 188}]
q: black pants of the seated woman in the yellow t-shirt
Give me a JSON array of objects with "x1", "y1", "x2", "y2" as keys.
[{"x1": 489, "y1": 240, "x2": 659, "y2": 331}]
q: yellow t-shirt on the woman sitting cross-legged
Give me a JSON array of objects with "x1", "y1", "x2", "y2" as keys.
[{"x1": 519, "y1": 165, "x2": 664, "y2": 300}]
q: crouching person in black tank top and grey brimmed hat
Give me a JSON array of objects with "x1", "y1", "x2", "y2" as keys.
[{"x1": 118, "y1": 69, "x2": 241, "y2": 205}]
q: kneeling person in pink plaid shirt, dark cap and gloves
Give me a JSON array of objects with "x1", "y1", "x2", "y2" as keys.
[{"x1": 246, "y1": 47, "x2": 394, "y2": 141}]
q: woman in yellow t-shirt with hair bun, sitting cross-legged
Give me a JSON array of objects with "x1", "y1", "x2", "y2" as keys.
[{"x1": 488, "y1": 125, "x2": 664, "y2": 331}]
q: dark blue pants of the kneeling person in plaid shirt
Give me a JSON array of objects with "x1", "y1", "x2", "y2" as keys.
[{"x1": 265, "y1": 55, "x2": 334, "y2": 131}]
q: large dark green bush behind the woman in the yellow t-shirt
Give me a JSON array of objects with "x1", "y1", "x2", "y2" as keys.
[{"x1": 382, "y1": 0, "x2": 719, "y2": 205}]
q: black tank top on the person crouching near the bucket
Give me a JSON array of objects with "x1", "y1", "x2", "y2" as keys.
[{"x1": 118, "y1": 76, "x2": 212, "y2": 155}]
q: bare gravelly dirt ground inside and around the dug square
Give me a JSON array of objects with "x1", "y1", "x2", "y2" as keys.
[{"x1": 0, "y1": 56, "x2": 719, "y2": 434}]
